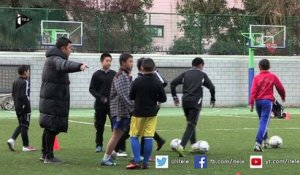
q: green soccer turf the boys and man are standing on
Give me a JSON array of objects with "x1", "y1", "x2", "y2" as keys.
[{"x1": 0, "y1": 108, "x2": 300, "y2": 175}]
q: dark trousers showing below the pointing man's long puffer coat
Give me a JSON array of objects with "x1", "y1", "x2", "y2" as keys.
[{"x1": 42, "y1": 129, "x2": 58, "y2": 159}]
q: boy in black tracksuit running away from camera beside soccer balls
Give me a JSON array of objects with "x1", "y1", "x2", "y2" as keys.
[{"x1": 171, "y1": 57, "x2": 216, "y2": 157}]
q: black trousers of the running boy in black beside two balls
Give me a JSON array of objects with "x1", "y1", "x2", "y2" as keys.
[{"x1": 180, "y1": 108, "x2": 200, "y2": 147}]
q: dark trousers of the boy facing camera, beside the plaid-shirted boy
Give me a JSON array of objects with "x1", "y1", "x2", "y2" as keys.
[{"x1": 94, "y1": 108, "x2": 112, "y2": 146}]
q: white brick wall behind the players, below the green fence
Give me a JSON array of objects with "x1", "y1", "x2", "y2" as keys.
[{"x1": 0, "y1": 52, "x2": 300, "y2": 108}]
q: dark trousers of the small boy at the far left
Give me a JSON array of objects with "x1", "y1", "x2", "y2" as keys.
[{"x1": 11, "y1": 112, "x2": 30, "y2": 147}]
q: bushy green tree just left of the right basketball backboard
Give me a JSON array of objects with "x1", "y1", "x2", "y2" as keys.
[{"x1": 178, "y1": 0, "x2": 248, "y2": 54}]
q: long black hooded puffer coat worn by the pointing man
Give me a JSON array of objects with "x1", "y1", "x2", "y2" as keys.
[{"x1": 39, "y1": 47, "x2": 82, "y2": 132}]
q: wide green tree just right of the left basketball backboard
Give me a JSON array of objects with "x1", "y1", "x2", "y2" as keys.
[{"x1": 68, "y1": 0, "x2": 152, "y2": 53}]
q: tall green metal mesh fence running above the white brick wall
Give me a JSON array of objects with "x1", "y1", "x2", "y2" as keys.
[{"x1": 0, "y1": 8, "x2": 300, "y2": 55}]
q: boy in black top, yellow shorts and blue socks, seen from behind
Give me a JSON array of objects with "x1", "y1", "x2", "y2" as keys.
[{"x1": 126, "y1": 58, "x2": 167, "y2": 169}]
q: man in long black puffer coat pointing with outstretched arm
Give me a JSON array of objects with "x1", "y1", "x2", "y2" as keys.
[{"x1": 39, "y1": 37, "x2": 88, "y2": 163}]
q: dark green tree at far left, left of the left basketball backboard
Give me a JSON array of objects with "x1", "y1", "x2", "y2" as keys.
[{"x1": 0, "y1": 0, "x2": 66, "y2": 51}]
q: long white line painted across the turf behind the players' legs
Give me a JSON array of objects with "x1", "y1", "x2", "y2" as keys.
[{"x1": 69, "y1": 120, "x2": 300, "y2": 132}]
